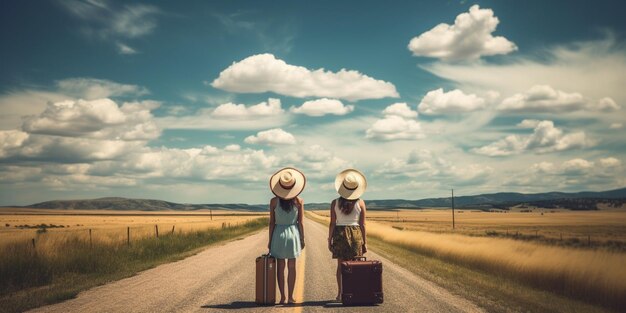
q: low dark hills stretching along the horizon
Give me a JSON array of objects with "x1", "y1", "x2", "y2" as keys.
[{"x1": 14, "y1": 188, "x2": 626, "y2": 211}]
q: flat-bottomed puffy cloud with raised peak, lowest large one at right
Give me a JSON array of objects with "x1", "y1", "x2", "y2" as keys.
[{"x1": 472, "y1": 120, "x2": 592, "y2": 156}]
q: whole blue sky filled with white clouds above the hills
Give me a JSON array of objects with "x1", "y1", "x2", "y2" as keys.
[{"x1": 0, "y1": 0, "x2": 626, "y2": 205}]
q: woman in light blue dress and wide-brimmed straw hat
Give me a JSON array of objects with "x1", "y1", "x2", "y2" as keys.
[{"x1": 267, "y1": 167, "x2": 306, "y2": 304}]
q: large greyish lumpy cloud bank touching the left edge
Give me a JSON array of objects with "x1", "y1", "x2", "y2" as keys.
[{"x1": 0, "y1": 99, "x2": 160, "y2": 163}]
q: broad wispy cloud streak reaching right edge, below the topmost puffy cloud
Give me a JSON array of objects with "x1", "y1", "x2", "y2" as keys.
[{"x1": 421, "y1": 33, "x2": 626, "y2": 103}]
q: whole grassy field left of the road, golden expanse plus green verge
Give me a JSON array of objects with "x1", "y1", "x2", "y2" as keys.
[{"x1": 0, "y1": 209, "x2": 268, "y2": 312}]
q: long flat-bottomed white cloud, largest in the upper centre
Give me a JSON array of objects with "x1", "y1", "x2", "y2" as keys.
[{"x1": 211, "y1": 54, "x2": 399, "y2": 101}]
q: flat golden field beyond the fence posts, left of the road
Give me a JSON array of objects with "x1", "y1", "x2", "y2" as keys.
[{"x1": 0, "y1": 208, "x2": 268, "y2": 248}]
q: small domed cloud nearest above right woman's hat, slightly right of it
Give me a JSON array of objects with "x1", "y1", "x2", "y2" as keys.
[{"x1": 365, "y1": 115, "x2": 425, "y2": 140}]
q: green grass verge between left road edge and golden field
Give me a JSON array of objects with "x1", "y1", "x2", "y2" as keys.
[{"x1": 0, "y1": 218, "x2": 268, "y2": 312}]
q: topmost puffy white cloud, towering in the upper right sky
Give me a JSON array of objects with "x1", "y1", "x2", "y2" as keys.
[{"x1": 408, "y1": 5, "x2": 517, "y2": 61}]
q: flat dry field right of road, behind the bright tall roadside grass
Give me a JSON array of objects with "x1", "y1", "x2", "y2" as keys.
[{"x1": 315, "y1": 209, "x2": 626, "y2": 251}]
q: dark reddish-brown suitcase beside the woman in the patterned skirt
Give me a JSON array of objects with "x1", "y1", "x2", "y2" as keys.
[{"x1": 341, "y1": 257, "x2": 383, "y2": 305}]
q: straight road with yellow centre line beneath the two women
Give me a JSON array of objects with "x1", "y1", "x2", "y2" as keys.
[{"x1": 33, "y1": 220, "x2": 482, "y2": 313}]
